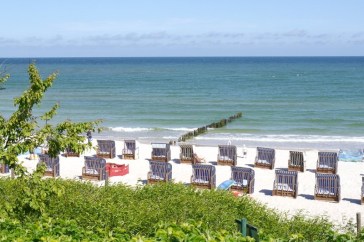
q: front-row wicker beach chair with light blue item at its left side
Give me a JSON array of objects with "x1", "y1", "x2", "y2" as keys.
[{"x1": 230, "y1": 166, "x2": 255, "y2": 194}]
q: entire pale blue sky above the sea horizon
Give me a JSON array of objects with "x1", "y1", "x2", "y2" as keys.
[{"x1": 0, "y1": 0, "x2": 364, "y2": 57}]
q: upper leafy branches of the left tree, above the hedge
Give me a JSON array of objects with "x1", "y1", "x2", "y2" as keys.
[{"x1": 0, "y1": 63, "x2": 101, "y2": 176}]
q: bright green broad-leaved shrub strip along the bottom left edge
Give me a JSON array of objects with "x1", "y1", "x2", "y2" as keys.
[{"x1": 0, "y1": 218, "x2": 250, "y2": 242}]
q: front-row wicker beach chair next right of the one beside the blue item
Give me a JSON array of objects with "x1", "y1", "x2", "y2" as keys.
[{"x1": 272, "y1": 170, "x2": 298, "y2": 198}]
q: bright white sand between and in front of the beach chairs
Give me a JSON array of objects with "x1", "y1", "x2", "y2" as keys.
[{"x1": 15, "y1": 141, "x2": 364, "y2": 224}]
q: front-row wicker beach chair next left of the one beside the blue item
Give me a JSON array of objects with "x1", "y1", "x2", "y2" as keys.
[{"x1": 191, "y1": 164, "x2": 216, "y2": 189}]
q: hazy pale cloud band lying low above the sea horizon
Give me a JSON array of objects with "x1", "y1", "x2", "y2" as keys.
[{"x1": 0, "y1": 29, "x2": 364, "y2": 56}]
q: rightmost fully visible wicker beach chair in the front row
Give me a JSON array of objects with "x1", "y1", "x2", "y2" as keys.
[{"x1": 314, "y1": 173, "x2": 341, "y2": 202}]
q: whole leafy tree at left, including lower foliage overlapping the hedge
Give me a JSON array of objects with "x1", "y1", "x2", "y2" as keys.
[{"x1": 0, "y1": 63, "x2": 101, "y2": 221}]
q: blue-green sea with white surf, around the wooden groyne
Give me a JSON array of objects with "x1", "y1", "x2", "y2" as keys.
[{"x1": 0, "y1": 57, "x2": 364, "y2": 150}]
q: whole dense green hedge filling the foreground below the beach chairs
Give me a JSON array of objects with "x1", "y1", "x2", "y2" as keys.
[{"x1": 0, "y1": 179, "x2": 364, "y2": 241}]
